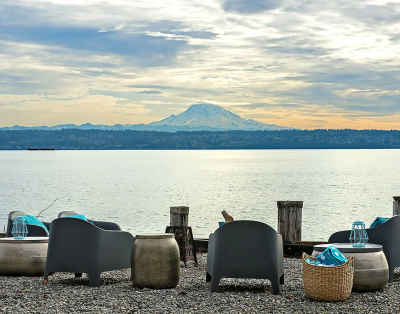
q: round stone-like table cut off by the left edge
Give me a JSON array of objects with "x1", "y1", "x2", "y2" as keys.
[{"x1": 0, "y1": 237, "x2": 49, "y2": 276}]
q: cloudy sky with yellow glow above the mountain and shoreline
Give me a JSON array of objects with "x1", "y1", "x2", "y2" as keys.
[{"x1": 0, "y1": 0, "x2": 400, "y2": 129}]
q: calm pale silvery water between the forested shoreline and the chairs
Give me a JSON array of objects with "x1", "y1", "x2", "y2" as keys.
[{"x1": 0, "y1": 150, "x2": 400, "y2": 240}]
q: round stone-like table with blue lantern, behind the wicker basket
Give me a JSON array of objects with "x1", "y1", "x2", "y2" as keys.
[{"x1": 312, "y1": 243, "x2": 389, "y2": 291}]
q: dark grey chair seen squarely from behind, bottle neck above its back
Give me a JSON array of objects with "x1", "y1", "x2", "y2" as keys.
[{"x1": 206, "y1": 220, "x2": 284, "y2": 294}]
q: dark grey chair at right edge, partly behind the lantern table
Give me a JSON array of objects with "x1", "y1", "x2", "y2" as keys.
[{"x1": 328, "y1": 216, "x2": 400, "y2": 283}]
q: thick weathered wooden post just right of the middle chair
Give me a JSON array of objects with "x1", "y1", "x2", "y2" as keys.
[{"x1": 277, "y1": 201, "x2": 303, "y2": 244}]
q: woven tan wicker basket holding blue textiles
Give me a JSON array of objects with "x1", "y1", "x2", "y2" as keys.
[{"x1": 303, "y1": 253, "x2": 354, "y2": 301}]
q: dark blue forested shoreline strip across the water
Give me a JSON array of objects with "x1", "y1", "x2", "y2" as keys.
[{"x1": 0, "y1": 129, "x2": 400, "y2": 150}]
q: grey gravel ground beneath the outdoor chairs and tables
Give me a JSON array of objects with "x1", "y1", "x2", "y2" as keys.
[{"x1": 0, "y1": 253, "x2": 400, "y2": 313}]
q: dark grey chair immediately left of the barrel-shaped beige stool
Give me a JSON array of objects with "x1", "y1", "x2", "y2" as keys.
[{"x1": 43, "y1": 218, "x2": 134, "y2": 287}]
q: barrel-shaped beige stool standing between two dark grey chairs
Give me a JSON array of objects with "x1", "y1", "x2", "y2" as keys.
[{"x1": 131, "y1": 233, "x2": 180, "y2": 289}]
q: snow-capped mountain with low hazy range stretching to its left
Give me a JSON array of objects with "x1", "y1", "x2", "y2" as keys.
[{"x1": 0, "y1": 104, "x2": 292, "y2": 132}]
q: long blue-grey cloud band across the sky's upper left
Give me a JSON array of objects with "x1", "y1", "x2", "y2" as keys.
[{"x1": 0, "y1": 26, "x2": 185, "y2": 67}]
